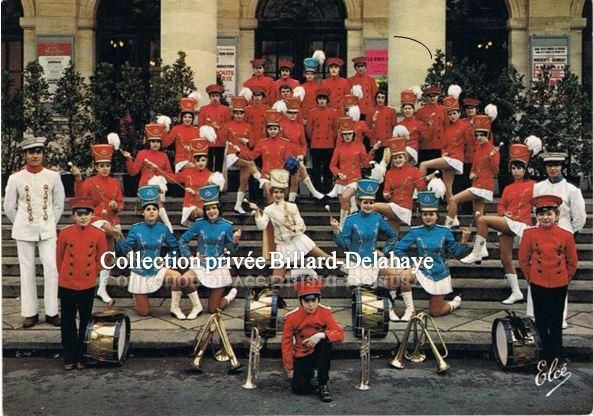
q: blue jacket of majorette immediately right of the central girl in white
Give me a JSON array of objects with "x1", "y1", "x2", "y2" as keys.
[{"x1": 334, "y1": 210, "x2": 397, "y2": 259}]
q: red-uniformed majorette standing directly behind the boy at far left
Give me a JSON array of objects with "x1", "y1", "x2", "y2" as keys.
[{"x1": 71, "y1": 144, "x2": 124, "y2": 305}]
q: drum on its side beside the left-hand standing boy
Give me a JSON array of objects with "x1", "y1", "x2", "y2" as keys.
[{"x1": 84, "y1": 309, "x2": 131, "y2": 365}]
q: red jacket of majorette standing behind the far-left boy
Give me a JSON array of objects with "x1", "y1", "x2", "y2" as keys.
[{"x1": 74, "y1": 175, "x2": 124, "y2": 225}]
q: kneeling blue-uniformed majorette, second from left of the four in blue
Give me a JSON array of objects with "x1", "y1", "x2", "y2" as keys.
[{"x1": 179, "y1": 185, "x2": 241, "y2": 312}]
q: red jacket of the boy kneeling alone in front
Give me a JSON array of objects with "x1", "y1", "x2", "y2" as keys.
[{"x1": 282, "y1": 305, "x2": 344, "y2": 370}]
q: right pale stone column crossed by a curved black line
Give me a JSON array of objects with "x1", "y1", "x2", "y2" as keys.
[{"x1": 387, "y1": 0, "x2": 447, "y2": 108}]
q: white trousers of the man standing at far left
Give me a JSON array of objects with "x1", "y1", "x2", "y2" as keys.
[{"x1": 16, "y1": 238, "x2": 58, "y2": 317}]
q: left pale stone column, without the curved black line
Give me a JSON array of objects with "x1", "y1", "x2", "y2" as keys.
[{"x1": 161, "y1": 0, "x2": 218, "y2": 105}]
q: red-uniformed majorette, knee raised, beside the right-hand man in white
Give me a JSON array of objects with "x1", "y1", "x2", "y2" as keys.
[{"x1": 461, "y1": 141, "x2": 541, "y2": 305}]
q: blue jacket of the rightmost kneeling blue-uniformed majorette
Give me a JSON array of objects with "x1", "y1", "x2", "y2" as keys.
[{"x1": 394, "y1": 225, "x2": 470, "y2": 282}]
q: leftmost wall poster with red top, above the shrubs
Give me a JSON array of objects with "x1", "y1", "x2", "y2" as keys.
[{"x1": 37, "y1": 36, "x2": 74, "y2": 94}]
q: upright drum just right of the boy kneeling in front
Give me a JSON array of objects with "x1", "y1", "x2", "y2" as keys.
[{"x1": 352, "y1": 287, "x2": 390, "y2": 338}]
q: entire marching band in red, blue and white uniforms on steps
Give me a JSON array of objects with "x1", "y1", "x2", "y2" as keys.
[{"x1": 4, "y1": 51, "x2": 586, "y2": 401}]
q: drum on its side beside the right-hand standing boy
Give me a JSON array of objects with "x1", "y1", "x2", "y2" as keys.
[{"x1": 492, "y1": 312, "x2": 541, "y2": 368}]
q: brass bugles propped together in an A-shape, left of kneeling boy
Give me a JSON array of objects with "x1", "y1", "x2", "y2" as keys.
[{"x1": 192, "y1": 309, "x2": 243, "y2": 374}]
